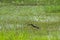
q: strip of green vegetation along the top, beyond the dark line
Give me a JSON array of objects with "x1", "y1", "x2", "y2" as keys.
[{"x1": 0, "y1": 0, "x2": 60, "y2": 5}]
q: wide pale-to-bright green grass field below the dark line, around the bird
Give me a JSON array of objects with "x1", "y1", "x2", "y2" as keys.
[{"x1": 0, "y1": 2, "x2": 60, "y2": 40}]
